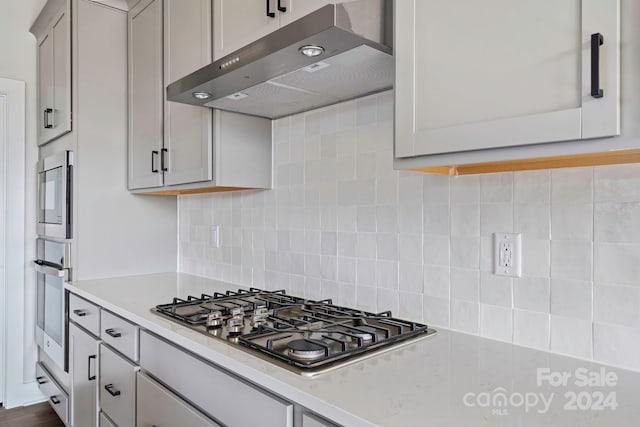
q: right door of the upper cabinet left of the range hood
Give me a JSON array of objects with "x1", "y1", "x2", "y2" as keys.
[{"x1": 164, "y1": 0, "x2": 212, "y2": 185}]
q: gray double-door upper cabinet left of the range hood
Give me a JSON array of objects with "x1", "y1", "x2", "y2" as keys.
[{"x1": 129, "y1": 0, "x2": 272, "y2": 195}]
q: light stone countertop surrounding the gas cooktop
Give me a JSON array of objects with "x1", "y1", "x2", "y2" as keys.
[{"x1": 65, "y1": 273, "x2": 640, "y2": 427}]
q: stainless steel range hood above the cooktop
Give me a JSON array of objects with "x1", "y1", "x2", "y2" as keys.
[{"x1": 167, "y1": 0, "x2": 394, "y2": 119}]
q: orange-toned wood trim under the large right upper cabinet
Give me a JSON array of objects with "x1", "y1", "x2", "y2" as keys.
[{"x1": 410, "y1": 149, "x2": 640, "y2": 176}]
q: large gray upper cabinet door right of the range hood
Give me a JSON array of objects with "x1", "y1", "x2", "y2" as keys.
[{"x1": 395, "y1": 0, "x2": 620, "y2": 157}]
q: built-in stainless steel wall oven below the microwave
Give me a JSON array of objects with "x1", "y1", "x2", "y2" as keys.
[{"x1": 34, "y1": 239, "x2": 71, "y2": 371}]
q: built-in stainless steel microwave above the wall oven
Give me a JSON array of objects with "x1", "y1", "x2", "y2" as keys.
[{"x1": 37, "y1": 151, "x2": 73, "y2": 239}]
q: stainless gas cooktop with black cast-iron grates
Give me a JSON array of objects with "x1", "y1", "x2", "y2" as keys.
[{"x1": 152, "y1": 288, "x2": 436, "y2": 376}]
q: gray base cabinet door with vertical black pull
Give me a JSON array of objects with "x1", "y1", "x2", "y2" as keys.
[{"x1": 69, "y1": 322, "x2": 98, "y2": 427}]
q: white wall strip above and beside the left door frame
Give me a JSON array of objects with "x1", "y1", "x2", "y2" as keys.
[{"x1": 0, "y1": 0, "x2": 46, "y2": 404}]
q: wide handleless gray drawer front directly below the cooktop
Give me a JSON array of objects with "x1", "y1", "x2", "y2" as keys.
[{"x1": 140, "y1": 331, "x2": 293, "y2": 427}]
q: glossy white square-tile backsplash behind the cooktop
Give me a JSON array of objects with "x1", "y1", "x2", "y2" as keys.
[{"x1": 179, "y1": 93, "x2": 640, "y2": 370}]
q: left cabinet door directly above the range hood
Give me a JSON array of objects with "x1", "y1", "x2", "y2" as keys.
[{"x1": 213, "y1": 0, "x2": 280, "y2": 60}]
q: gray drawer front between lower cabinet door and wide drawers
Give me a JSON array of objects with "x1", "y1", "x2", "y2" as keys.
[{"x1": 99, "y1": 345, "x2": 137, "y2": 427}]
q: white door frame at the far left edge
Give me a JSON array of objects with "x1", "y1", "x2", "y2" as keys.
[{"x1": 0, "y1": 78, "x2": 42, "y2": 408}]
